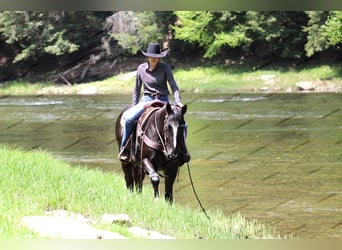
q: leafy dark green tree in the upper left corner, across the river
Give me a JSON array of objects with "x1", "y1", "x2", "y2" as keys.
[{"x1": 0, "y1": 11, "x2": 102, "y2": 62}]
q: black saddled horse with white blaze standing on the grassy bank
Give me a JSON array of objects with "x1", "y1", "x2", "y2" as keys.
[{"x1": 115, "y1": 103, "x2": 190, "y2": 203}]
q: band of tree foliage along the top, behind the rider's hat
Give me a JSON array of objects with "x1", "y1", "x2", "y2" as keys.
[{"x1": 0, "y1": 11, "x2": 342, "y2": 78}]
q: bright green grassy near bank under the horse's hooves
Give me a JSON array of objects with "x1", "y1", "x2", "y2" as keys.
[{"x1": 0, "y1": 146, "x2": 281, "y2": 239}]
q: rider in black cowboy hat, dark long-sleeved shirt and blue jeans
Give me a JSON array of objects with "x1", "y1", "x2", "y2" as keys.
[{"x1": 119, "y1": 43, "x2": 184, "y2": 161}]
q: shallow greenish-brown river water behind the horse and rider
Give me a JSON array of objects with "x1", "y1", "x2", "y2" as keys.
[{"x1": 0, "y1": 93, "x2": 342, "y2": 239}]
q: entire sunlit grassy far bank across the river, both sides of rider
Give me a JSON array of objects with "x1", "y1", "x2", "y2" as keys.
[{"x1": 0, "y1": 64, "x2": 342, "y2": 95}]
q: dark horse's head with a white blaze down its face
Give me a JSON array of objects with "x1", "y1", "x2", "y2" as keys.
[{"x1": 163, "y1": 103, "x2": 187, "y2": 160}]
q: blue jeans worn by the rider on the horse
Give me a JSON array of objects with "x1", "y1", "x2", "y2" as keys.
[{"x1": 120, "y1": 95, "x2": 169, "y2": 151}]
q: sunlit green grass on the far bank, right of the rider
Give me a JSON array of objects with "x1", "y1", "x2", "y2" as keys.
[{"x1": 175, "y1": 64, "x2": 342, "y2": 92}]
